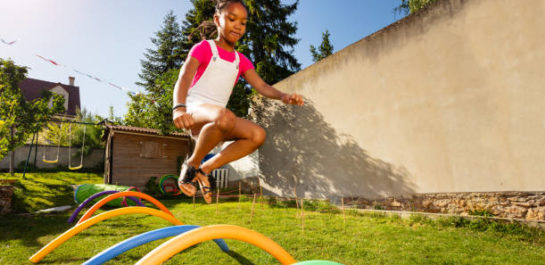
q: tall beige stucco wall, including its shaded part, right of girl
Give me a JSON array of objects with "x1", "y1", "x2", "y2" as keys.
[{"x1": 254, "y1": 0, "x2": 545, "y2": 198}]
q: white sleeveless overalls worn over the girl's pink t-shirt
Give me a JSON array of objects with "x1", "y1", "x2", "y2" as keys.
[{"x1": 186, "y1": 40, "x2": 240, "y2": 108}]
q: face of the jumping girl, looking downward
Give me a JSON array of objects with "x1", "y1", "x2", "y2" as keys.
[{"x1": 214, "y1": 3, "x2": 248, "y2": 46}]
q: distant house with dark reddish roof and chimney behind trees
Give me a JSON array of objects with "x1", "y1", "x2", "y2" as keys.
[{"x1": 19, "y1": 76, "x2": 81, "y2": 118}]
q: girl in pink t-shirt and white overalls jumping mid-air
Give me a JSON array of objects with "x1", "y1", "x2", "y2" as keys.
[{"x1": 172, "y1": 0, "x2": 304, "y2": 203}]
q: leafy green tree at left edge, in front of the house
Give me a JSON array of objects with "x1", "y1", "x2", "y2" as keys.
[{"x1": 0, "y1": 59, "x2": 64, "y2": 174}]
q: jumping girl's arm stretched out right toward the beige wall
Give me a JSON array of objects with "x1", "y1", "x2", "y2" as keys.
[{"x1": 243, "y1": 69, "x2": 304, "y2": 106}]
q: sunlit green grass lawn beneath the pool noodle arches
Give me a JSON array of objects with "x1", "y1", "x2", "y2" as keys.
[{"x1": 0, "y1": 173, "x2": 545, "y2": 265}]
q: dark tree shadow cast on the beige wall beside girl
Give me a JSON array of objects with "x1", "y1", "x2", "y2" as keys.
[{"x1": 252, "y1": 98, "x2": 414, "y2": 201}]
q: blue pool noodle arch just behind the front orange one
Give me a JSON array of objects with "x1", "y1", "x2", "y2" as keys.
[{"x1": 82, "y1": 225, "x2": 229, "y2": 265}]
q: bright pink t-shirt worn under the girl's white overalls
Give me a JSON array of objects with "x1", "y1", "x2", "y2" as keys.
[{"x1": 189, "y1": 40, "x2": 254, "y2": 87}]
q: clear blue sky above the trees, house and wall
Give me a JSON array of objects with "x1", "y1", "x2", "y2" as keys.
[{"x1": 0, "y1": 0, "x2": 402, "y2": 116}]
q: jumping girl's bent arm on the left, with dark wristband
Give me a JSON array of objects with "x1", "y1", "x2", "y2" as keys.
[{"x1": 172, "y1": 56, "x2": 199, "y2": 129}]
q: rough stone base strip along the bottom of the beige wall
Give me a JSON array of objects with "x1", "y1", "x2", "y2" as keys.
[{"x1": 344, "y1": 192, "x2": 545, "y2": 221}]
